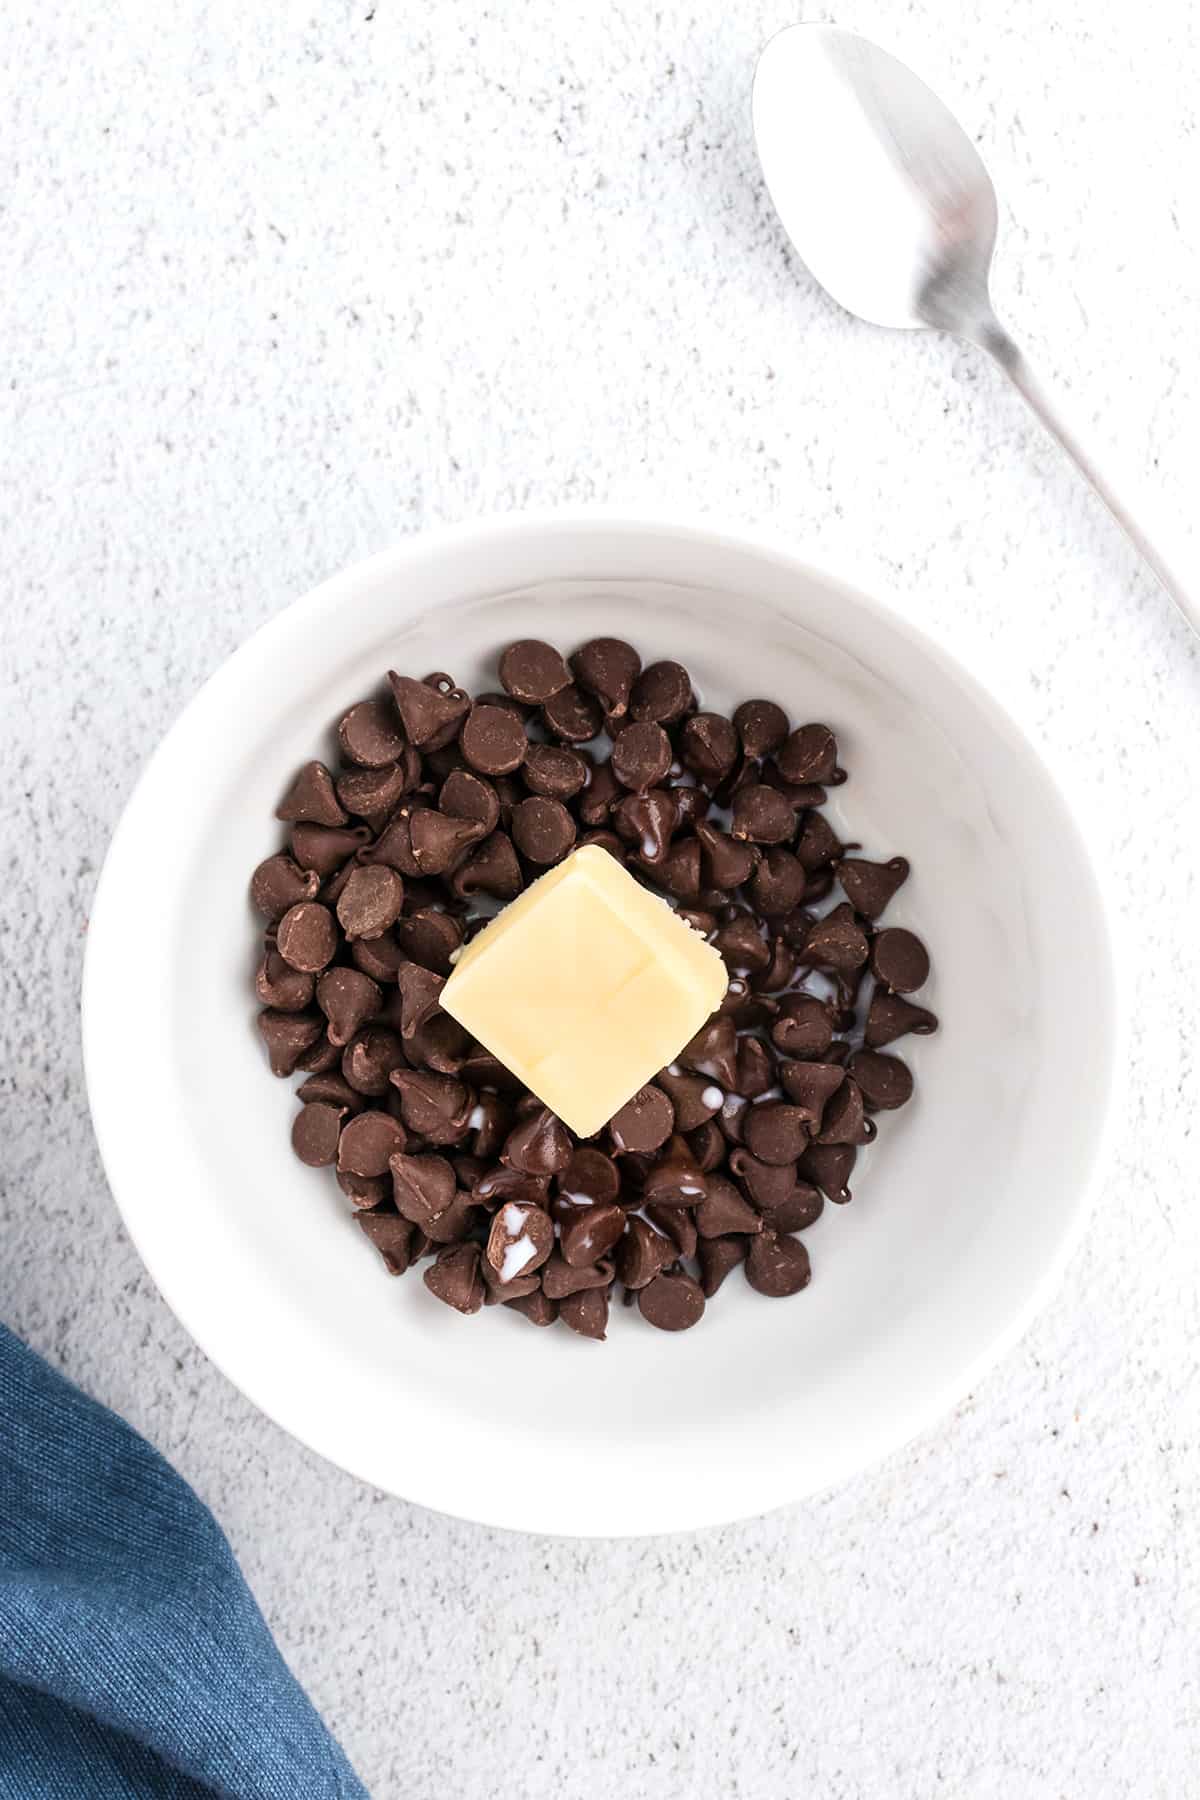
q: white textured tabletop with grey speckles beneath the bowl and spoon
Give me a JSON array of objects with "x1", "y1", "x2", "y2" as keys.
[{"x1": 0, "y1": 0, "x2": 1200, "y2": 1800}]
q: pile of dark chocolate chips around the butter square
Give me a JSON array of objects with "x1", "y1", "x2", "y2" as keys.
[{"x1": 250, "y1": 637, "x2": 937, "y2": 1337}]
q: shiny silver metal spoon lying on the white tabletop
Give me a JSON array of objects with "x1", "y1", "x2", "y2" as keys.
[{"x1": 754, "y1": 25, "x2": 1200, "y2": 634}]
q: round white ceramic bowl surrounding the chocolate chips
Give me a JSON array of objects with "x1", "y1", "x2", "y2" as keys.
[{"x1": 85, "y1": 513, "x2": 1115, "y2": 1535}]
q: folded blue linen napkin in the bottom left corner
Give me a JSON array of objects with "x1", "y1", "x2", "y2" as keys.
[{"x1": 0, "y1": 1325, "x2": 365, "y2": 1800}]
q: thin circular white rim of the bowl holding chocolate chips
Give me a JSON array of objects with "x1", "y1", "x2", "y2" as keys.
[{"x1": 81, "y1": 504, "x2": 1128, "y2": 1537}]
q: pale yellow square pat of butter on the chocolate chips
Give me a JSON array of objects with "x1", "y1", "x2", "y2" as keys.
[{"x1": 441, "y1": 844, "x2": 729, "y2": 1138}]
